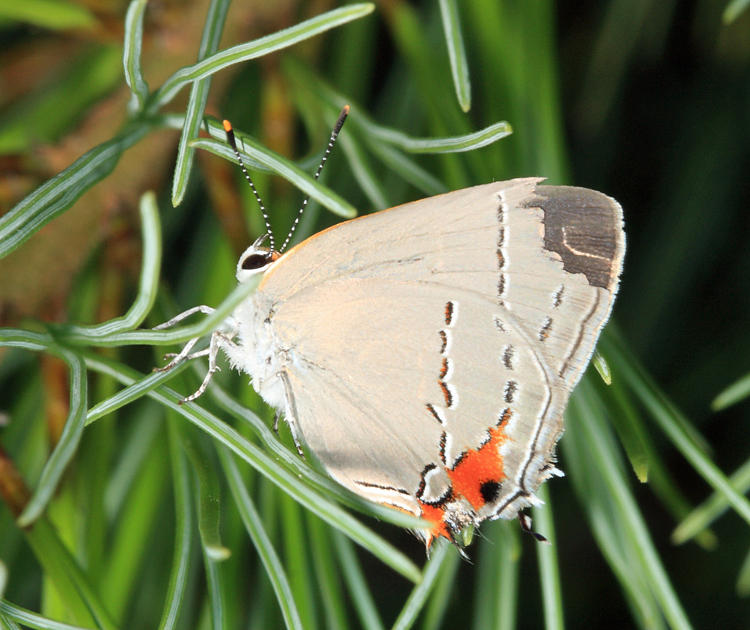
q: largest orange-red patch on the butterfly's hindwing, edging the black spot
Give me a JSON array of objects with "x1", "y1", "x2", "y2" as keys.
[{"x1": 448, "y1": 424, "x2": 509, "y2": 510}]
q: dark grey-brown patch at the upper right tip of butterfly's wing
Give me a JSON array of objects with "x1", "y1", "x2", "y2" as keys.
[{"x1": 521, "y1": 186, "x2": 623, "y2": 290}]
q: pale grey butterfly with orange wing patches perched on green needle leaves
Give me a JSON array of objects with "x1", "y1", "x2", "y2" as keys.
[{"x1": 162, "y1": 107, "x2": 625, "y2": 546}]
